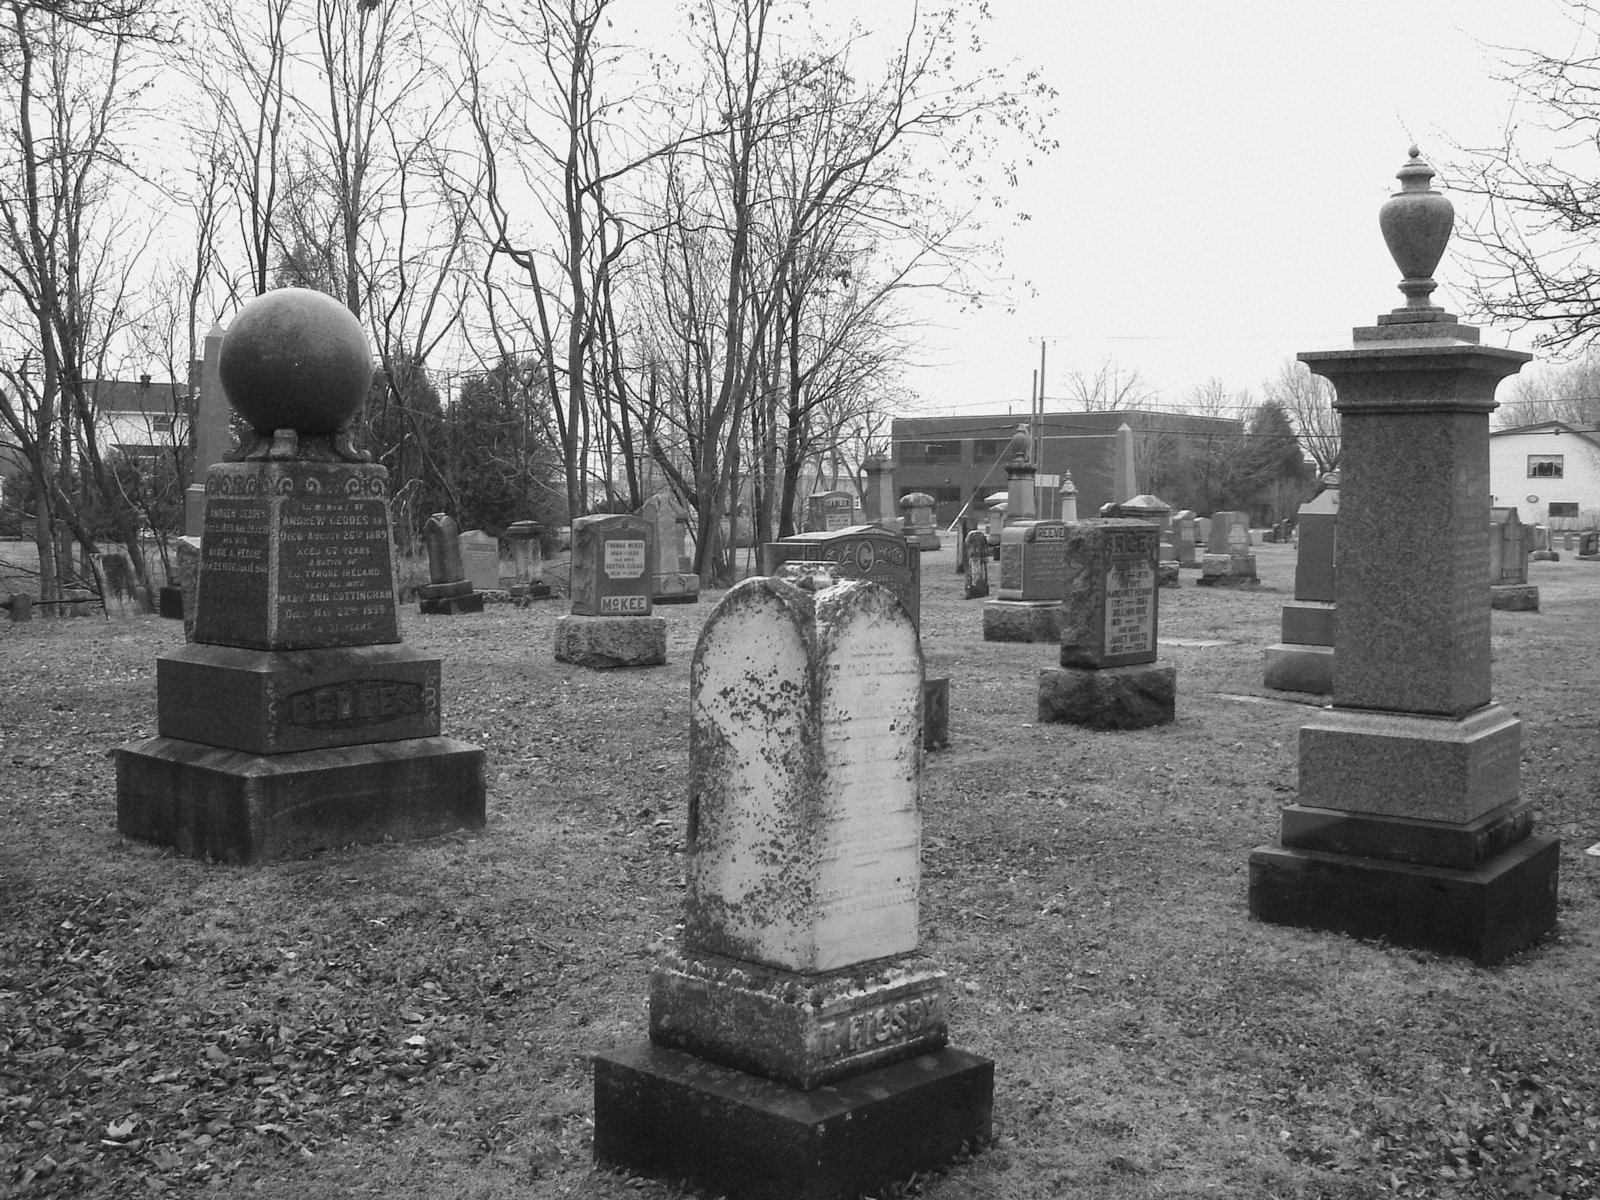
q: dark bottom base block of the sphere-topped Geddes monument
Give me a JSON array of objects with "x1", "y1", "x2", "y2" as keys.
[{"x1": 117, "y1": 738, "x2": 485, "y2": 862}]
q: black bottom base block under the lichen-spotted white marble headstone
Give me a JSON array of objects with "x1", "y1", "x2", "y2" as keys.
[{"x1": 594, "y1": 1045, "x2": 994, "y2": 1200}]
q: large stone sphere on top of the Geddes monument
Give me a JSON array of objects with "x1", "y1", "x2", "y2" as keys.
[{"x1": 218, "y1": 288, "x2": 373, "y2": 434}]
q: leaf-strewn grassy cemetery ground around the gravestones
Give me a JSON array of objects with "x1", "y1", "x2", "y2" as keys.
[{"x1": 0, "y1": 544, "x2": 1600, "y2": 1200}]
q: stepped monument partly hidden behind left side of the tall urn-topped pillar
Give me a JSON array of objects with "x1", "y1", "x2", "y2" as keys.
[{"x1": 1264, "y1": 475, "x2": 1339, "y2": 696}]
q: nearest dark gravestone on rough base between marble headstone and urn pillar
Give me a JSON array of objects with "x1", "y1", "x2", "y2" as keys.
[{"x1": 1038, "y1": 517, "x2": 1178, "y2": 730}]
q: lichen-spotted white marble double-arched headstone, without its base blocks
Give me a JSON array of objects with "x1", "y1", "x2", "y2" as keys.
[{"x1": 685, "y1": 578, "x2": 922, "y2": 973}]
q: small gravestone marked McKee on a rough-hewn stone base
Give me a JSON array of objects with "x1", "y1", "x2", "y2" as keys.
[{"x1": 555, "y1": 515, "x2": 667, "y2": 667}]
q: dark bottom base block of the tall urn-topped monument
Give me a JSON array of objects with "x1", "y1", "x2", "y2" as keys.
[{"x1": 1250, "y1": 835, "x2": 1560, "y2": 966}]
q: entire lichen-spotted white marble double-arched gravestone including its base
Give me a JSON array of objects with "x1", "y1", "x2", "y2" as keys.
[{"x1": 594, "y1": 571, "x2": 994, "y2": 1197}]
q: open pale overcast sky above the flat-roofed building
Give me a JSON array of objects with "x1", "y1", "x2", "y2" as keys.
[{"x1": 752, "y1": 0, "x2": 1574, "y2": 413}]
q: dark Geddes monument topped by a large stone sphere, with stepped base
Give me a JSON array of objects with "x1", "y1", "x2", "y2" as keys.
[{"x1": 117, "y1": 288, "x2": 485, "y2": 862}]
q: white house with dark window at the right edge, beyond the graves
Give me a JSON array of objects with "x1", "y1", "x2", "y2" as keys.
[{"x1": 1490, "y1": 421, "x2": 1600, "y2": 530}]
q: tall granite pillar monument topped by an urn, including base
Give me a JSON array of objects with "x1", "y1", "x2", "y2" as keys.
[{"x1": 1250, "y1": 147, "x2": 1560, "y2": 963}]
